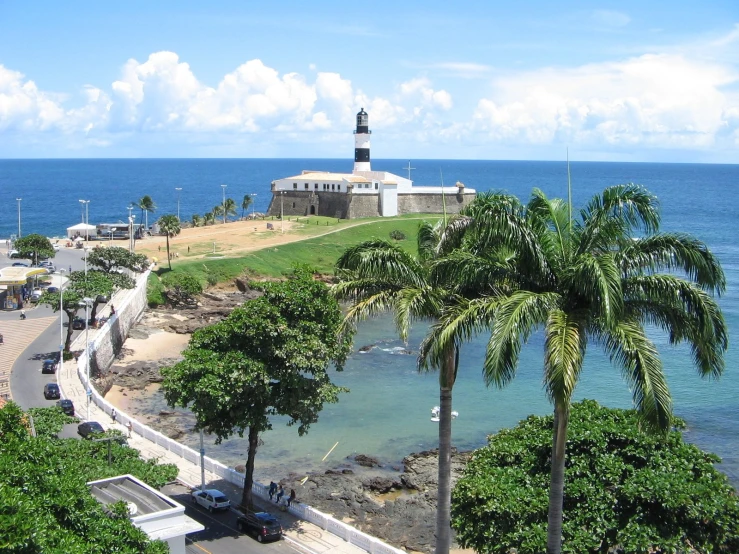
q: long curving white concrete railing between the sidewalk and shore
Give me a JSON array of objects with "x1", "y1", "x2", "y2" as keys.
[{"x1": 70, "y1": 271, "x2": 407, "y2": 554}]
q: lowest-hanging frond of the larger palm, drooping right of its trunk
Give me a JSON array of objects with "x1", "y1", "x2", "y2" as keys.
[{"x1": 596, "y1": 314, "x2": 672, "y2": 433}]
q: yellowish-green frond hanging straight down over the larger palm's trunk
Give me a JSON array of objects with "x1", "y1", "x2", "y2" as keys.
[{"x1": 544, "y1": 309, "x2": 587, "y2": 406}]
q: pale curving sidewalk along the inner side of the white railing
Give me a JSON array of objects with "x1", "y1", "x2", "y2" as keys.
[{"x1": 57, "y1": 320, "x2": 366, "y2": 554}]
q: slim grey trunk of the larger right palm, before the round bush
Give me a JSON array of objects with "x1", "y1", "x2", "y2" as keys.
[{"x1": 547, "y1": 402, "x2": 570, "y2": 554}]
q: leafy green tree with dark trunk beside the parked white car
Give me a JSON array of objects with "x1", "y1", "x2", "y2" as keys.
[{"x1": 162, "y1": 268, "x2": 351, "y2": 506}]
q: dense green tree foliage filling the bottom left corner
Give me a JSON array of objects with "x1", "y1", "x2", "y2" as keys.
[{"x1": 0, "y1": 402, "x2": 177, "y2": 554}]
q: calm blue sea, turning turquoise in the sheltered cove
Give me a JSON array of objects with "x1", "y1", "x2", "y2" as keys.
[{"x1": 0, "y1": 159, "x2": 739, "y2": 485}]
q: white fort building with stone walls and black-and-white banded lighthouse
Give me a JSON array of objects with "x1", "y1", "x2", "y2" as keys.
[{"x1": 267, "y1": 108, "x2": 475, "y2": 219}]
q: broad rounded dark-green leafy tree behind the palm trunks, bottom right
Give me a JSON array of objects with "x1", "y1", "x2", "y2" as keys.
[{"x1": 452, "y1": 400, "x2": 739, "y2": 554}]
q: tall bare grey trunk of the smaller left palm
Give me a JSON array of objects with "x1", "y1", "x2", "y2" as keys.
[{"x1": 434, "y1": 347, "x2": 456, "y2": 554}]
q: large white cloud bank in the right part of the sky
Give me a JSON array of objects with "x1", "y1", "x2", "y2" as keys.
[{"x1": 474, "y1": 55, "x2": 738, "y2": 148}]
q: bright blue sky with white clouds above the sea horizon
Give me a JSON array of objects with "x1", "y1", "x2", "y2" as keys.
[{"x1": 0, "y1": 0, "x2": 739, "y2": 163}]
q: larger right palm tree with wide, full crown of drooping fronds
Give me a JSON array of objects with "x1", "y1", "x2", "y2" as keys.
[{"x1": 431, "y1": 185, "x2": 728, "y2": 554}]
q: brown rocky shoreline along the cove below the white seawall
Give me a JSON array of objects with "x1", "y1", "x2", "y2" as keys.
[{"x1": 96, "y1": 283, "x2": 470, "y2": 552}]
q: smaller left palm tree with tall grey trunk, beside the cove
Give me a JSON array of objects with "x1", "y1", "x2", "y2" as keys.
[{"x1": 332, "y1": 221, "x2": 459, "y2": 554}]
